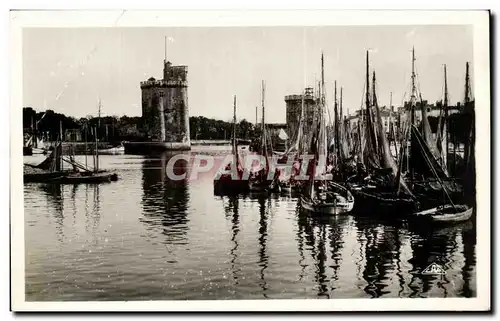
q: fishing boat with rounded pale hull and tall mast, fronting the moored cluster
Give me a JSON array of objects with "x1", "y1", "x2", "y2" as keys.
[{"x1": 300, "y1": 54, "x2": 354, "y2": 215}]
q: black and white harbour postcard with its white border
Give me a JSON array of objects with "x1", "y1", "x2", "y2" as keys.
[{"x1": 10, "y1": 10, "x2": 491, "y2": 311}]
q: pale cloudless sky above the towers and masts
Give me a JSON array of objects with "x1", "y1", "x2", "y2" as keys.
[{"x1": 22, "y1": 25, "x2": 474, "y2": 123}]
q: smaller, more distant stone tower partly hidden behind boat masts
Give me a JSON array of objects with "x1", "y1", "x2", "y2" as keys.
[{"x1": 285, "y1": 88, "x2": 319, "y2": 138}]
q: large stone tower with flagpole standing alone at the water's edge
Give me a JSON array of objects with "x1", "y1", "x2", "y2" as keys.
[{"x1": 125, "y1": 60, "x2": 191, "y2": 154}]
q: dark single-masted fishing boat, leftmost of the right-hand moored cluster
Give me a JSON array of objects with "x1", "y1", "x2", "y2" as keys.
[{"x1": 214, "y1": 96, "x2": 248, "y2": 195}]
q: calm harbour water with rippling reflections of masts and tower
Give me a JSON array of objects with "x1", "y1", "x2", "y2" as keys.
[{"x1": 24, "y1": 150, "x2": 476, "y2": 301}]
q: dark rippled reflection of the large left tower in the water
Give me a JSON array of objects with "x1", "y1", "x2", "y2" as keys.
[{"x1": 140, "y1": 153, "x2": 189, "y2": 244}]
